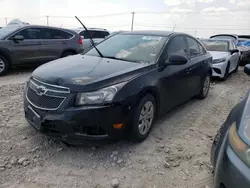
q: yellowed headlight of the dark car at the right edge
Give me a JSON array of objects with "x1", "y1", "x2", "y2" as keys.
[{"x1": 229, "y1": 122, "x2": 250, "y2": 166}]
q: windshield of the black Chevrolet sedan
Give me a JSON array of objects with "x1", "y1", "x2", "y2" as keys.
[{"x1": 86, "y1": 34, "x2": 167, "y2": 62}]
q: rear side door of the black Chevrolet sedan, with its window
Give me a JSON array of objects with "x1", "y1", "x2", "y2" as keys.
[{"x1": 185, "y1": 36, "x2": 207, "y2": 97}]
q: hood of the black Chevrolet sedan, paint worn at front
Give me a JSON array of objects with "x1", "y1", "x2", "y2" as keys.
[{"x1": 32, "y1": 55, "x2": 155, "y2": 91}]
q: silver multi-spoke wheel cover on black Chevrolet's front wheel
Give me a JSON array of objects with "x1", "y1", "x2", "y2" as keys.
[{"x1": 138, "y1": 101, "x2": 154, "y2": 135}]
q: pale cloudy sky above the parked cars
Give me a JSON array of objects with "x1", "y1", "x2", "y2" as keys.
[{"x1": 0, "y1": 0, "x2": 250, "y2": 38}]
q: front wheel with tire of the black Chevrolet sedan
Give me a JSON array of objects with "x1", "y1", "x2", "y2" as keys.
[{"x1": 131, "y1": 94, "x2": 156, "y2": 141}]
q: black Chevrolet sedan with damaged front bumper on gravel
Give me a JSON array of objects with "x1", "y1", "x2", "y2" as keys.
[{"x1": 24, "y1": 31, "x2": 212, "y2": 141}]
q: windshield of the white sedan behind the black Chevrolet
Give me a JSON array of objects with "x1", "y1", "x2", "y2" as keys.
[{"x1": 201, "y1": 40, "x2": 229, "y2": 52}]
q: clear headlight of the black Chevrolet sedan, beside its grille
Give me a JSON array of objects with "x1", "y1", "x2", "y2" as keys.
[{"x1": 75, "y1": 82, "x2": 126, "y2": 106}]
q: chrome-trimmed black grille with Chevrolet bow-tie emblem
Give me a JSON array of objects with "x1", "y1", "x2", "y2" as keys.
[{"x1": 26, "y1": 79, "x2": 70, "y2": 110}]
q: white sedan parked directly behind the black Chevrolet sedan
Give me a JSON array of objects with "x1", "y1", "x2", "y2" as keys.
[{"x1": 201, "y1": 39, "x2": 240, "y2": 80}]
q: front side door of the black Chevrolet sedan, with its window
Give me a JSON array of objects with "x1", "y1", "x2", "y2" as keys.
[{"x1": 159, "y1": 35, "x2": 189, "y2": 111}]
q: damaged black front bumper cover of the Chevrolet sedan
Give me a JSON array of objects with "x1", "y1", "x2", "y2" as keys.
[{"x1": 24, "y1": 99, "x2": 129, "y2": 139}]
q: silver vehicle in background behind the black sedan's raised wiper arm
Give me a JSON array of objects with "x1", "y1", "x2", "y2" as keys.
[{"x1": 74, "y1": 28, "x2": 110, "y2": 51}]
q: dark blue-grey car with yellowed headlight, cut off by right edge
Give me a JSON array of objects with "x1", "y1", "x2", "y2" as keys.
[{"x1": 211, "y1": 65, "x2": 250, "y2": 188}]
